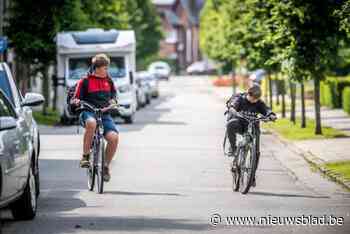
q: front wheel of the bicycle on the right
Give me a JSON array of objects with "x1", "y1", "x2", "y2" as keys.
[{"x1": 239, "y1": 145, "x2": 256, "y2": 194}]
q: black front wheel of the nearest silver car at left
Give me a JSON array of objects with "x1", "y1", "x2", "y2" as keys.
[{"x1": 10, "y1": 166, "x2": 37, "y2": 220}]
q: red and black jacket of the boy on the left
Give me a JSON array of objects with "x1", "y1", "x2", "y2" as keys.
[{"x1": 74, "y1": 74, "x2": 116, "y2": 108}]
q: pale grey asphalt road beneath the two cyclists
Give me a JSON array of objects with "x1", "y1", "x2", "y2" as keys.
[{"x1": 2, "y1": 77, "x2": 350, "y2": 234}]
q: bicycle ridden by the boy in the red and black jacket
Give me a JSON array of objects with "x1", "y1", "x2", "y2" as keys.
[{"x1": 79, "y1": 101, "x2": 117, "y2": 194}]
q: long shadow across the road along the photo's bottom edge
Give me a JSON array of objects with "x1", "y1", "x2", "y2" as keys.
[{"x1": 2, "y1": 215, "x2": 210, "y2": 234}]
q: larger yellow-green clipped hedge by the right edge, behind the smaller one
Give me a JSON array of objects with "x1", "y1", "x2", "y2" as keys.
[{"x1": 320, "y1": 77, "x2": 350, "y2": 108}]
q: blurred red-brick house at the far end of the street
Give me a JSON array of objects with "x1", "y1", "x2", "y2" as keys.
[{"x1": 153, "y1": 0, "x2": 205, "y2": 70}]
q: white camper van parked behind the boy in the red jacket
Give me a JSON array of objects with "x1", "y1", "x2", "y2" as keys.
[{"x1": 56, "y1": 29, "x2": 137, "y2": 123}]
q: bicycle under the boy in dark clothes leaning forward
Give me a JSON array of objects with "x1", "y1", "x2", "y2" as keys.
[{"x1": 223, "y1": 112, "x2": 272, "y2": 194}]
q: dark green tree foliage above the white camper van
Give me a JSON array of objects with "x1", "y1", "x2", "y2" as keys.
[{"x1": 6, "y1": 0, "x2": 162, "y2": 70}]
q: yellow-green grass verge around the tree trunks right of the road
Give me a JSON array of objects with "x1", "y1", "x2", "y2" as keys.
[{"x1": 263, "y1": 118, "x2": 346, "y2": 140}]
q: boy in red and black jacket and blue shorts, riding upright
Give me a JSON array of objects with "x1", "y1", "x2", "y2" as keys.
[{"x1": 72, "y1": 54, "x2": 119, "y2": 181}]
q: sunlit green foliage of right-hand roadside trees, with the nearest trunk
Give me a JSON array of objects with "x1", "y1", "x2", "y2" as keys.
[{"x1": 200, "y1": 0, "x2": 350, "y2": 133}]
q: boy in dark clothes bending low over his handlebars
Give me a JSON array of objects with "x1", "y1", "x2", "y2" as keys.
[{"x1": 226, "y1": 84, "x2": 277, "y2": 185}]
